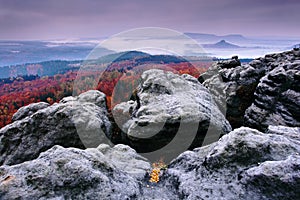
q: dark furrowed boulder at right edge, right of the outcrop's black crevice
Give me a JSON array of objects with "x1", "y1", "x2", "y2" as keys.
[{"x1": 244, "y1": 51, "x2": 300, "y2": 131}]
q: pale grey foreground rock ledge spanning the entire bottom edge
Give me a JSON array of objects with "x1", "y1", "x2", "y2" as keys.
[{"x1": 0, "y1": 126, "x2": 300, "y2": 200}]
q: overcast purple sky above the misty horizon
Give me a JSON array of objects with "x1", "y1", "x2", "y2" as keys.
[{"x1": 0, "y1": 0, "x2": 300, "y2": 40}]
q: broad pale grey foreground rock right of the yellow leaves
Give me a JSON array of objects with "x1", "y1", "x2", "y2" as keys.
[{"x1": 162, "y1": 127, "x2": 300, "y2": 200}]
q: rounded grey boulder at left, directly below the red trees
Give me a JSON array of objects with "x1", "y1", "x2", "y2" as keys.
[{"x1": 0, "y1": 90, "x2": 110, "y2": 165}]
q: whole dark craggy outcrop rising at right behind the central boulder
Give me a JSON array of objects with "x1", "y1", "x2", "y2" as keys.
[{"x1": 198, "y1": 50, "x2": 300, "y2": 131}]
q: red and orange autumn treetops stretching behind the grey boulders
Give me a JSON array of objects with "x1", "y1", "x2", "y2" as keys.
[{"x1": 0, "y1": 61, "x2": 211, "y2": 128}]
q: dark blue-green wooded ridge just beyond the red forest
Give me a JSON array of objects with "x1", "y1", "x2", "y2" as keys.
[{"x1": 0, "y1": 51, "x2": 186, "y2": 79}]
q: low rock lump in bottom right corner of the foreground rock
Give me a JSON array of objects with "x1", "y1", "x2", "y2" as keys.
[{"x1": 241, "y1": 154, "x2": 300, "y2": 199}]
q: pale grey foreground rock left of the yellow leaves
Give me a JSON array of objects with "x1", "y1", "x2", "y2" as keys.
[{"x1": 0, "y1": 145, "x2": 150, "y2": 200}]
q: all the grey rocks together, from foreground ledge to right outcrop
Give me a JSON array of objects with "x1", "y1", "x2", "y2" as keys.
[{"x1": 0, "y1": 49, "x2": 300, "y2": 200}]
